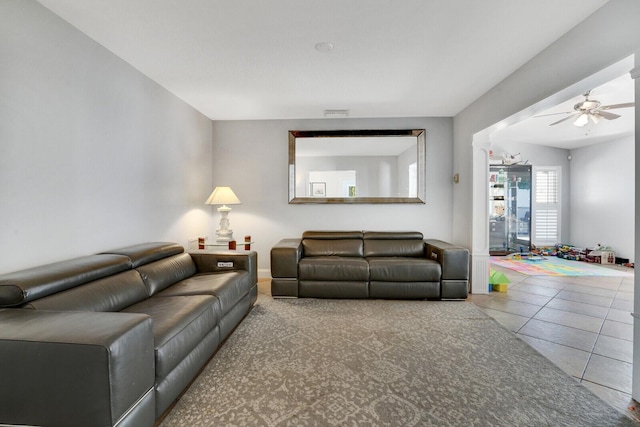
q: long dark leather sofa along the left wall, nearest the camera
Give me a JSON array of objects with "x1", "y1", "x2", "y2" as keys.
[{"x1": 0, "y1": 243, "x2": 257, "y2": 427}]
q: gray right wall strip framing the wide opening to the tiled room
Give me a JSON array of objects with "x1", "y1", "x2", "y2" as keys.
[{"x1": 453, "y1": 0, "x2": 640, "y2": 252}]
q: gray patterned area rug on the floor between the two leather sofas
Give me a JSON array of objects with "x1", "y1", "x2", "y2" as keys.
[{"x1": 161, "y1": 294, "x2": 636, "y2": 427}]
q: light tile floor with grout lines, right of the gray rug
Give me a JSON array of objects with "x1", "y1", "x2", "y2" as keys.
[{"x1": 470, "y1": 265, "x2": 640, "y2": 425}]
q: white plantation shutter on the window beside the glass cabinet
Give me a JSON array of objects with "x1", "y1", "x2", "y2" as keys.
[{"x1": 532, "y1": 167, "x2": 560, "y2": 246}]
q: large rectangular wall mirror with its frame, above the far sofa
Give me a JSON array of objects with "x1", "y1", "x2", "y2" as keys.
[{"x1": 289, "y1": 129, "x2": 426, "y2": 203}]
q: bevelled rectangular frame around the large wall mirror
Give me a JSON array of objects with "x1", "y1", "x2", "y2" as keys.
[{"x1": 289, "y1": 129, "x2": 426, "y2": 204}]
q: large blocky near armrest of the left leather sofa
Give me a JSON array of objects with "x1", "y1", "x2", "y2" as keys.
[{"x1": 0, "y1": 309, "x2": 155, "y2": 426}]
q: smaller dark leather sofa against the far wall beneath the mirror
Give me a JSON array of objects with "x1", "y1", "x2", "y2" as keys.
[{"x1": 271, "y1": 231, "x2": 469, "y2": 299}]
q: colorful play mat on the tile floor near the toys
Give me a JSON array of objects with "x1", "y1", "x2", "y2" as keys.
[{"x1": 490, "y1": 257, "x2": 633, "y2": 277}]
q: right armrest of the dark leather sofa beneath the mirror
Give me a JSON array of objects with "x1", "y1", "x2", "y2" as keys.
[{"x1": 425, "y1": 239, "x2": 469, "y2": 298}]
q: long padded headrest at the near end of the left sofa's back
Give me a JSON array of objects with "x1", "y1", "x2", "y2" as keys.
[{"x1": 0, "y1": 255, "x2": 131, "y2": 307}]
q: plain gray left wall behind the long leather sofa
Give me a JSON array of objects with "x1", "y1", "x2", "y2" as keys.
[{"x1": 0, "y1": 0, "x2": 212, "y2": 272}]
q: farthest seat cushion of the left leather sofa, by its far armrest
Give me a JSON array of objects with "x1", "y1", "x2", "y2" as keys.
[{"x1": 158, "y1": 270, "x2": 251, "y2": 316}]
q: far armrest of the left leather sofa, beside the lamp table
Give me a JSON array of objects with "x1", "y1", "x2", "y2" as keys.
[{"x1": 189, "y1": 251, "x2": 258, "y2": 283}]
